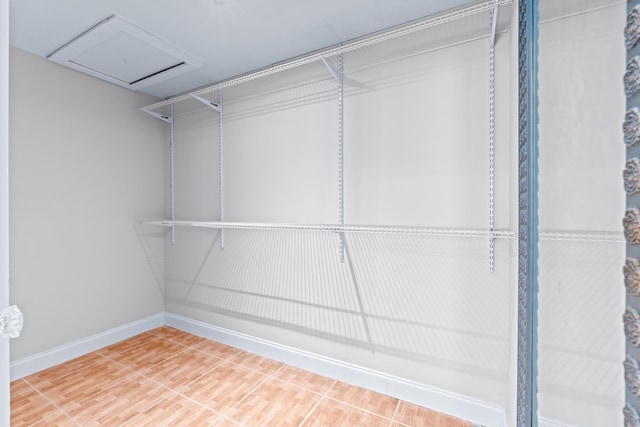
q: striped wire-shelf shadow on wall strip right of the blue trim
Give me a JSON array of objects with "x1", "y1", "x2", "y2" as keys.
[{"x1": 538, "y1": 239, "x2": 625, "y2": 411}]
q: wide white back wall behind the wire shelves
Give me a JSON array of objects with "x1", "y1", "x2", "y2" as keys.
[{"x1": 166, "y1": 20, "x2": 517, "y2": 414}]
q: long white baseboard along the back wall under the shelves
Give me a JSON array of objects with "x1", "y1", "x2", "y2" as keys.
[{"x1": 165, "y1": 313, "x2": 507, "y2": 427}]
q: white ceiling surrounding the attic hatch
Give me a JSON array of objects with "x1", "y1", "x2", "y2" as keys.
[{"x1": 10, "y1": 0, "x2": 470, "y2": 98}]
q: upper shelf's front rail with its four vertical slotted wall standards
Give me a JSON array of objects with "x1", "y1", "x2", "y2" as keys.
[{"x1": 141, "y1": 0, "x2": 513, "y2": 264}]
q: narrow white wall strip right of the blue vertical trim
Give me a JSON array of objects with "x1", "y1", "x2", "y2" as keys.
[{"x1": 538, "y1": 0, "x2": 625, "y2": 427}]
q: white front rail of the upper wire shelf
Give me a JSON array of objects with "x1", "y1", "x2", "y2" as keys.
[{"x1": 141, "y1": 0, "x2": 513, "y2": 110}]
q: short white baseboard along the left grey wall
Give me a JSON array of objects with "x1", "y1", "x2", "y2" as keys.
[{"x1": 10, "y1": 313, "x2": 165, "y2": 381}]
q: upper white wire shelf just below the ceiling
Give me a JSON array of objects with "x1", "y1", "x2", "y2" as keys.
[{"x1": 142, "y1": 0, "x2": 513, "y2": 116}]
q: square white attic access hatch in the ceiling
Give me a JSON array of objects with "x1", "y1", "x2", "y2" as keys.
[{"x1": 47, "y1": 15, "x2": 203, "y2": 90}]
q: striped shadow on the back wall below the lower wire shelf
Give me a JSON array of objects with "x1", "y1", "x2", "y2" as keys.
[{"x1": 139, "y1": 226, "x2": 515, "y2": 382}]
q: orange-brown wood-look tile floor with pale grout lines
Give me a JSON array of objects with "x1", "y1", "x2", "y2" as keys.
[{"x1": 11, "y1": 326, "x2": 471, "y2": 427}]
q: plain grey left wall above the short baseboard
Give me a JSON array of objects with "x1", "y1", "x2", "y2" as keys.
[{"x1": 10, "y1": 49, "x2": 165, "y2": 360}]
